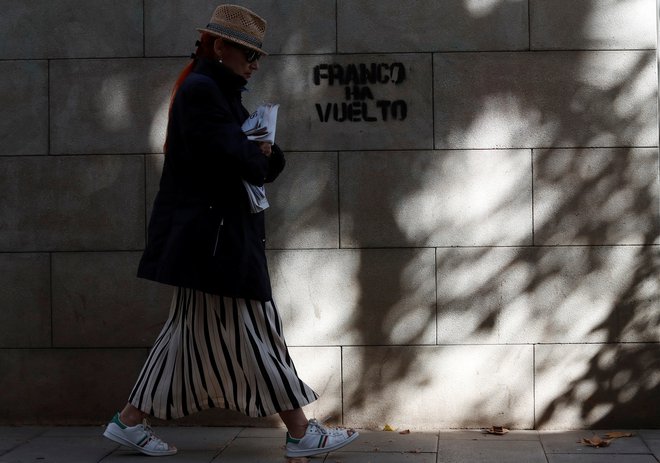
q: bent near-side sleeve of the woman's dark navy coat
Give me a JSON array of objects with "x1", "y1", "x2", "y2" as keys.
[{"x1": 178, "y1": 79, "x2": 271, "y2": 186}]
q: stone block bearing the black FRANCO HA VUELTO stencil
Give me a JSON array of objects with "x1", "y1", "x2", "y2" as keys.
[{"x1": 245, "y1": 54, "x2": 433, "y2": 151}]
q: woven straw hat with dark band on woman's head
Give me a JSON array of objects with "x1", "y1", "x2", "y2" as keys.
[{"x1": 197, "y1": 5, "x2": 268, "y2": 55}]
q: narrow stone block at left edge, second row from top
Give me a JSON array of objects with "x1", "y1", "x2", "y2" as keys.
[{"x1": 0, "y1": 60, "x2": 48, "y2": 156}]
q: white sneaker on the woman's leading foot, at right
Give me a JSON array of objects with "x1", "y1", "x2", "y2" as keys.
[{"x1": 286, "y1": 420, "x2": 359, "y2": 457}]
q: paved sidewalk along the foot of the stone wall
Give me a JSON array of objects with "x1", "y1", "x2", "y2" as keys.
[{"x1": 0, "y1": 427, "x2": 660, "y2": 463}]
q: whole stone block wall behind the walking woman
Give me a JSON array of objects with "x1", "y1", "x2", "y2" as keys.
[{"x1": 0, "y1": 0, "x2": 660, "y2": 430}]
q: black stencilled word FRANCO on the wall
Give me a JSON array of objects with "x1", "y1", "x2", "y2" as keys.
[{"x1": 314, "y1": 63, "x2": 406, "y2": 85}]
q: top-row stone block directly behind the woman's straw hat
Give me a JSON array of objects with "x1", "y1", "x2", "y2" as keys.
[{"x1": 145, "y1": 0, "x2": 336, "y2": 56}]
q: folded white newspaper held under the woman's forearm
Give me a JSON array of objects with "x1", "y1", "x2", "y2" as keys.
[{"x1": 241, "y1": 103, "x2": 280, "y2": 214}]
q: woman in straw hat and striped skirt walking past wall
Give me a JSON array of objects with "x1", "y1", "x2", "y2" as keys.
[{"x1": 104, "y1": 5, "x2": 358, "y2": 457}]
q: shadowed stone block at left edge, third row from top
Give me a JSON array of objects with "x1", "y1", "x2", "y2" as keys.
[{"x1": 0, "y1": 156, "x2": 144, "y2": 252}]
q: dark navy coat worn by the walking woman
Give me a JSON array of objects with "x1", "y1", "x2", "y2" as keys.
[{"x1": 138, "y1": 59, "x2": 284, "y2": 300}]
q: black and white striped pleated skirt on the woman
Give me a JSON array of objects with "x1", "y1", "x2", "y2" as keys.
[{"x1": 129, "y1": 288, "x2": 318, "y2": 419}]
